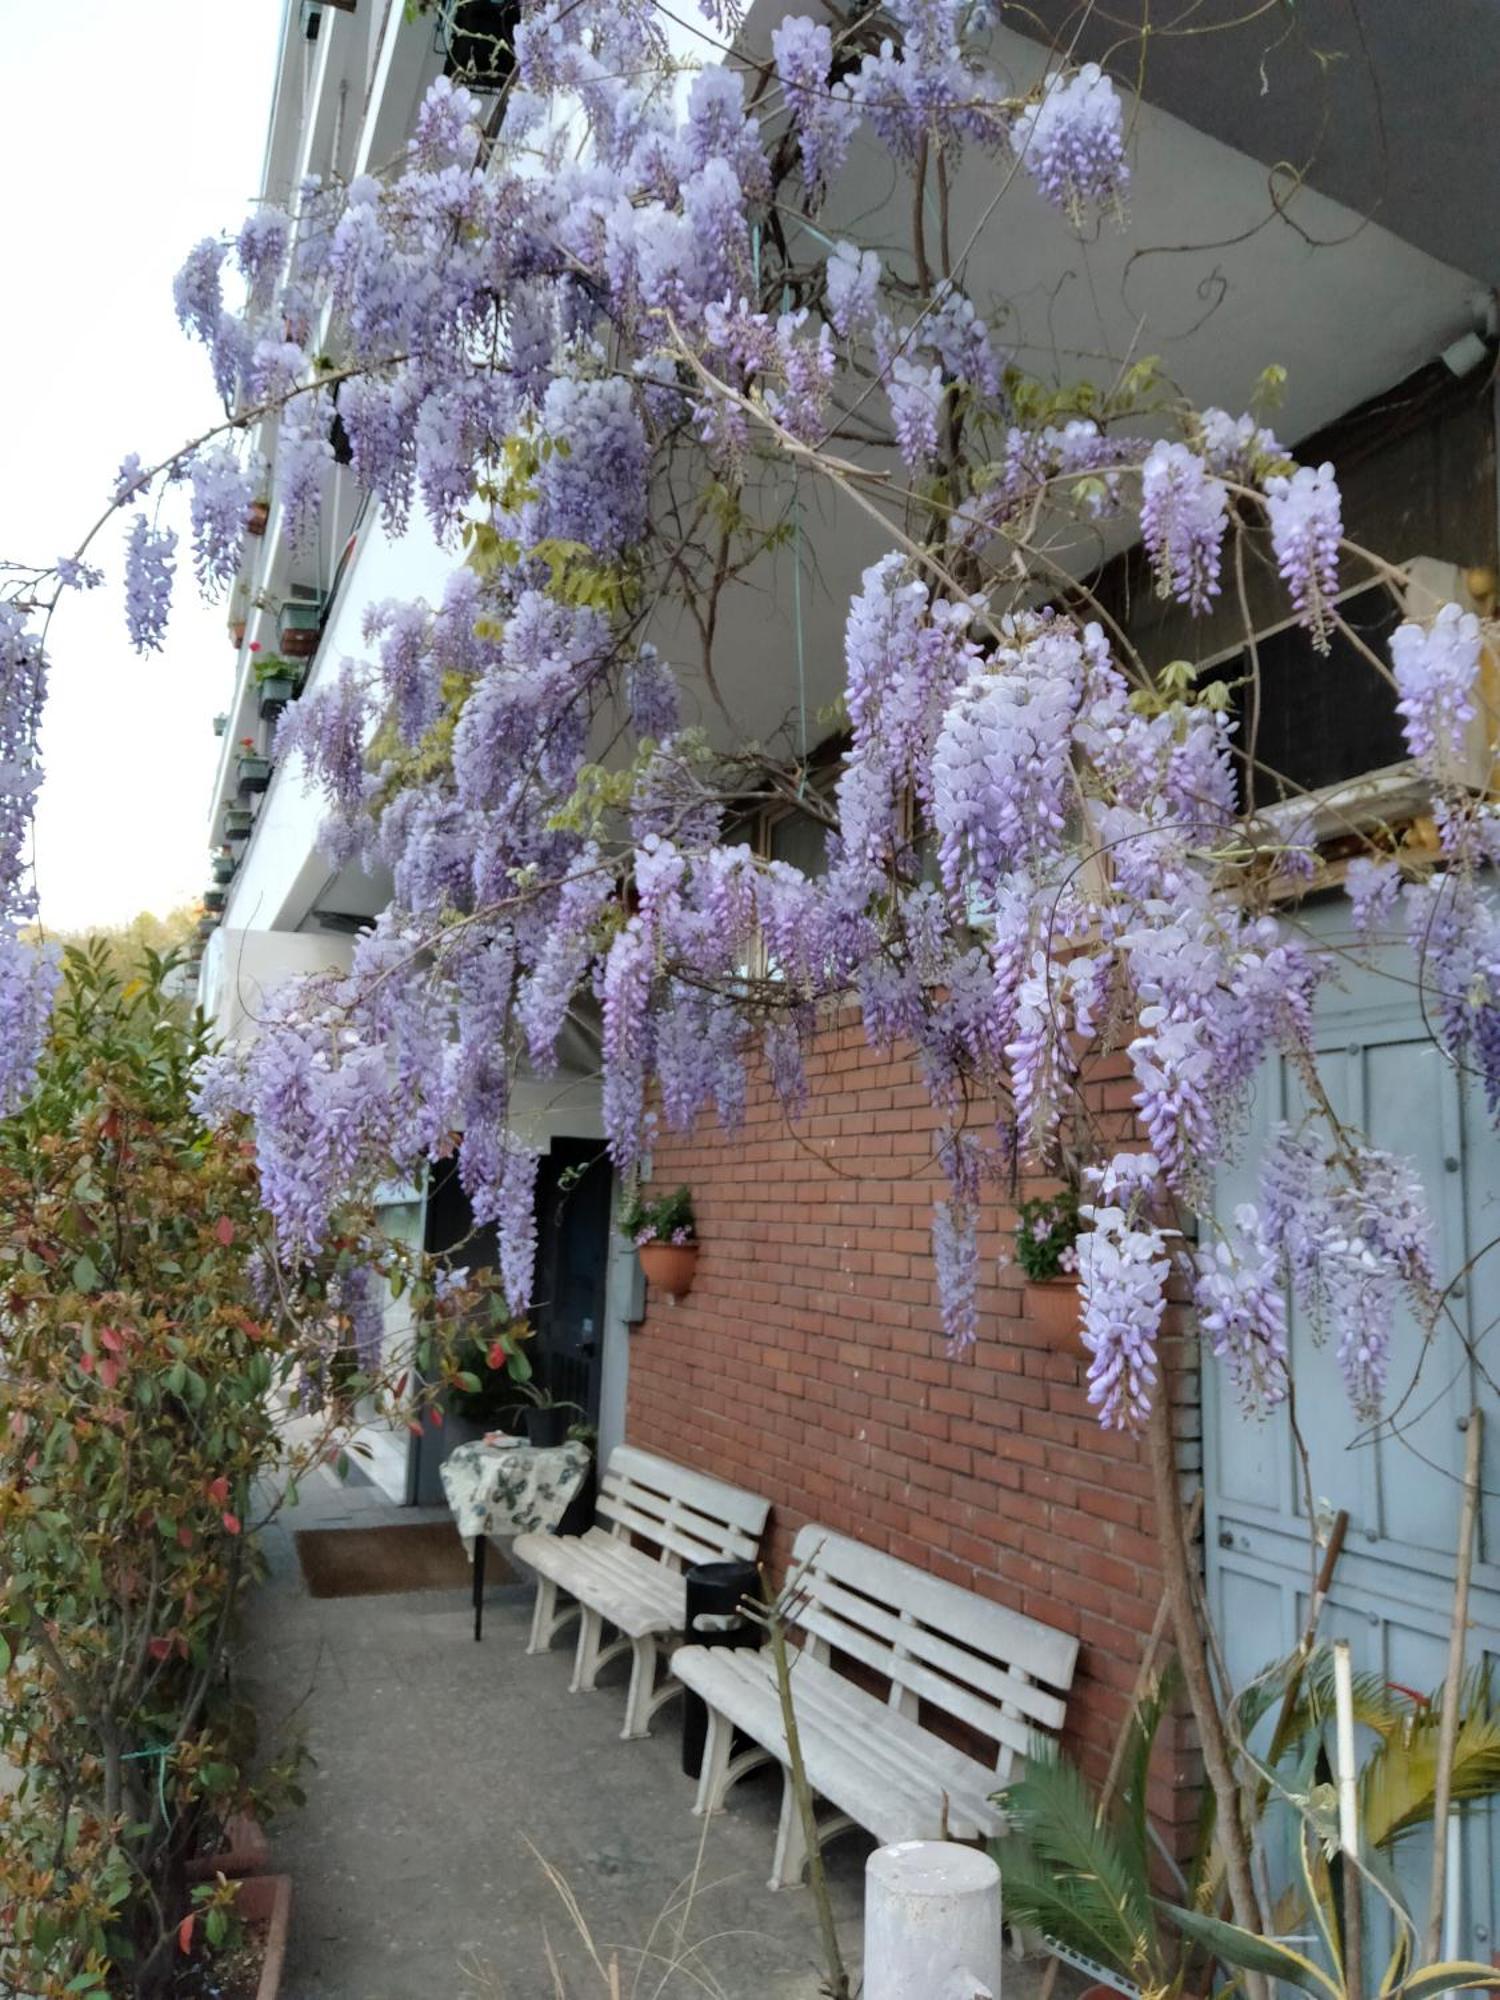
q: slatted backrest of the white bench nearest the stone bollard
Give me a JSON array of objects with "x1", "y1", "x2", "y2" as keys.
[{"x1": 786, "y1": 1522, "x2": 1078, "y2": 1784}]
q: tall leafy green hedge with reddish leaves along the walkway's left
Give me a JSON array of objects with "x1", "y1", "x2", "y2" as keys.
[{"x1": 0, "y1": 940, "x2": 512, "y2": 2000}]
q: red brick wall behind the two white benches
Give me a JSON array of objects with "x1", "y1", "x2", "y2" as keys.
[{"x1": 626, "y1": 1018, "x2": 1196, "y2": 1826}]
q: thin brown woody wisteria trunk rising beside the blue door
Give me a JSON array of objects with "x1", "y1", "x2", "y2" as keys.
[{"x1": 1146, "y1": 1370, "x2": 1264, "y2": 1976}]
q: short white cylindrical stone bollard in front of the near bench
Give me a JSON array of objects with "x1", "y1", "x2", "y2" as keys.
[{"x1": 862, "y1": 1840, "x2": 1000, "y2": 2000}]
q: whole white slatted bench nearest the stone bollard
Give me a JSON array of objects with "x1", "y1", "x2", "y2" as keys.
[{"x1": 672, "y1": 1526, "x2": 1078, "y2": 1888}]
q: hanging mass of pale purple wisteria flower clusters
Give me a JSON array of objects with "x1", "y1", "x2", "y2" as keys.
[{"x1": 0, "y1": 0, "x2": 1500, "y2": 1426}]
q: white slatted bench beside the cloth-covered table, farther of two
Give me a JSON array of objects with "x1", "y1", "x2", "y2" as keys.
[{"x1": 512, "y1": 1444, "x2": 770, "y2": 1740}]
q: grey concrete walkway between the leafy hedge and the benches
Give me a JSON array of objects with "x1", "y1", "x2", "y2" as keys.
[{"x1": 242, "y1": 1472, "x2": 892, "y2": 2000}]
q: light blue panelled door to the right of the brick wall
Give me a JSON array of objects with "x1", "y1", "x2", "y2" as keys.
[{"x1": 1204, "y1": 912, "x2": 1500, "y2": 1960}]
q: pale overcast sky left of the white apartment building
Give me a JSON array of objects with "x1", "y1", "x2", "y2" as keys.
[{"x1": 0, "y1": 0, "x2": 282, "y2": 930}]
